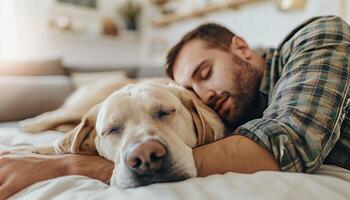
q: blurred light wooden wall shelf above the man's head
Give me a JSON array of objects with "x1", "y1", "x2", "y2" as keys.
[{"x1": 153, "y1": 0, "x2": 268, "y2": 27}]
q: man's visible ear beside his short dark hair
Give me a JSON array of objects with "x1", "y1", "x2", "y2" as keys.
[{"x1": 230, "y1": 36, "x2": 253, "y2": 60}]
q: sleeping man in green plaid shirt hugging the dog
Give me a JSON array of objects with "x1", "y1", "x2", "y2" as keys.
[{"x1": 0, "y1": 16, "x2": 350, "y2": 199}]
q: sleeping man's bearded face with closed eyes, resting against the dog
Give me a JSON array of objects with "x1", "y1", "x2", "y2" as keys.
[{"x1": 173, "y1": 39, "x2": 258, "y2": 126}]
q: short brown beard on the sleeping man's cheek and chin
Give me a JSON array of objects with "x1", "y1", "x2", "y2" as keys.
[{"x1": 218, "y1": 55, "x2": 259, "y2": 128}]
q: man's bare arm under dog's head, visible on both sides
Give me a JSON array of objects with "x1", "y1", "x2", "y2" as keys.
[{"x1": 0, "y1": 135, "x2": 279, "y2": 200}]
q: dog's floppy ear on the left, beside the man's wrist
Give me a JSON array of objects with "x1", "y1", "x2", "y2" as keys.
[{"x1": 55, "y1": 106, "x2": 99, "y2": 154}]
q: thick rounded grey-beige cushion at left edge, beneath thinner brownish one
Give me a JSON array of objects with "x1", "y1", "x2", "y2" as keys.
[{"x1": 0, "y1": 76, "x2": 73, "y2": 122}]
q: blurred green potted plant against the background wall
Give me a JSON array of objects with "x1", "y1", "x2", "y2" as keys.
[{"x1": 118, "y1": 0, "x2": 142, "y2": 31}]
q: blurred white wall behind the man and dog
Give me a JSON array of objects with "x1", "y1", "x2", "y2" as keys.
[{"x1": 0, "y1": 0, "x2": 350, "y2": 68}]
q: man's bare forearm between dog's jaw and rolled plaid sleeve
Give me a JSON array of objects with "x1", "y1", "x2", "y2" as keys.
[{"x1": 193, "y1": 135, "x2": 279, "y2": 176}]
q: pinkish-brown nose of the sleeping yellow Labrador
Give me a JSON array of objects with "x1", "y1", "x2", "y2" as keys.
[{"x1": 125, "y1": 140, "x2": 168, "y2": 176}]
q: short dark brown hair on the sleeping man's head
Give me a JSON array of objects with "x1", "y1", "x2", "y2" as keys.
[{"x1": 165, "y1": 23, "x2": 235, "y2": 79}]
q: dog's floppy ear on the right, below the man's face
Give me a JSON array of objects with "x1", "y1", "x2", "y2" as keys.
[{"x1": 169, "y1": 84, "x2": 224, "y2": 145}]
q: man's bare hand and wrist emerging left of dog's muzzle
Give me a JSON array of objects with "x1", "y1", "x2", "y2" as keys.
[{"x1": 0, "y1": 154, "x2": 114, "y2": 200}]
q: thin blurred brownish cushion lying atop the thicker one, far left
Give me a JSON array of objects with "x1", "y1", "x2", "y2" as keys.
[{"x1": 0, "y1": 59, "x2": 67, "y2": 76}]
